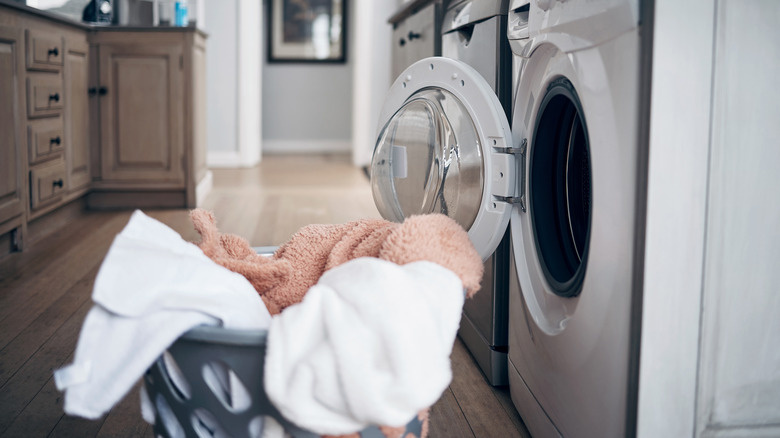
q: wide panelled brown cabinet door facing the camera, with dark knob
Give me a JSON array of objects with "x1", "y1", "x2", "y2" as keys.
[{"x1": 98, "y1": 44, "x2": 184, "y2": 186}]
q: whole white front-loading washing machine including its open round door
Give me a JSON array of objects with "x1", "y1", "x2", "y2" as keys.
[{"x1": 372, "y1": 0, "x2": 649, "y2": 437}]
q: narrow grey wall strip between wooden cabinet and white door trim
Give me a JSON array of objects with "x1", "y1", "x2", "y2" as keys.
[{"x1": 205, "y1": 0, "x2": 238, "y2": 151}]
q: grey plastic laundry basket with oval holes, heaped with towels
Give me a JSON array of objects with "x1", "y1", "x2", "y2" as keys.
[{"x1": 144, "y1": 326, "x2": 422, "y2": 438}]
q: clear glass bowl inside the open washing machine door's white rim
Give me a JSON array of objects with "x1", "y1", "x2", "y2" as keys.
[{"x1": 371, "y1": 88, "x2": 484, "y2": 229}]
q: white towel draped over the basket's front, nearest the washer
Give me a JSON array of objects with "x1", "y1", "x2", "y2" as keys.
[{"x1": 264, "y1": 258, "x2": 464, "y2": 435}]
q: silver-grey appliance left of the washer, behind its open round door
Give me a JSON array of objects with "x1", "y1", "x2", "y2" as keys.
[{"x1": 441, "y1": 0, "x2": 512, "y2": 386}]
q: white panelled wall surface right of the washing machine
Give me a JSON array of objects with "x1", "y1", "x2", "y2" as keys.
[{"x1": 637, "y1": 0, "x2": 780, "y2": 438}]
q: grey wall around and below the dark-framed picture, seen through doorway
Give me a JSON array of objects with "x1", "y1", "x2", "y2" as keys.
[{"x1": 266, "y1": 0, "x2": 356, "y2": 152}]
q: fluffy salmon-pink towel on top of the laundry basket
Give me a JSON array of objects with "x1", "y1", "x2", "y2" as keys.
[{"x1": 190, "y1": 209, "x2": 482, "y2": 315}]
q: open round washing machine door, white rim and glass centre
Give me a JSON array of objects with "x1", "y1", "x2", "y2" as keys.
[{"x1": 371, "y1": 57, "x2": 518, "y2": 260}]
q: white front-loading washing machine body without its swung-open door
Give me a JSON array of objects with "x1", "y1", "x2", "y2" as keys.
[{"x1": 507, "y1": 0, "x2": 645, "y2": 437}]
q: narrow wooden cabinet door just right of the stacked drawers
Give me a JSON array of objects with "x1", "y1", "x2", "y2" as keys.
[{"x1": 64, "y1": 39, "x2": 90, "y2": 190}]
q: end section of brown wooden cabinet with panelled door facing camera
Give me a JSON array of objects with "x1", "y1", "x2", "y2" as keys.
[{"x1": 88, "y1": 29, "x2": 205, "y2": 209}]
